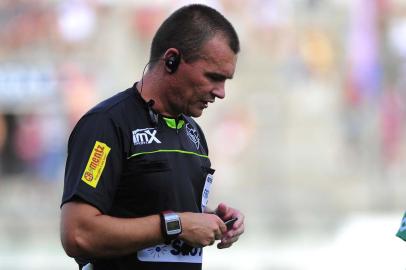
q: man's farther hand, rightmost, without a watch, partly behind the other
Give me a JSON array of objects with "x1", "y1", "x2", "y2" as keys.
[{"x1": 215, "y1": 203, "x2": 244, "y2": 249}]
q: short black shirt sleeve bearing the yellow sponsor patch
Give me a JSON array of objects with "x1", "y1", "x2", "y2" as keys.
[{"x1": 62, "y1": 112, "x2": 123, "y2": 213}]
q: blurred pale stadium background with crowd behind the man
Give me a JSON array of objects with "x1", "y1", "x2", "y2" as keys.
[{"x1": 0, "y1": 0, "x2": 406, "y2": 270}]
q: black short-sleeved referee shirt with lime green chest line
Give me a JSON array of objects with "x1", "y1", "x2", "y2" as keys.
[{"x1": 62, "y1": 86, "x2": 214, "y2": 270}]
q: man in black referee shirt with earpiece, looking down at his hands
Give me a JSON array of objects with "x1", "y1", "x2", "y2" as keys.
[{"x1": 61, "y1": 5, "x2": 244, "y2": 270}]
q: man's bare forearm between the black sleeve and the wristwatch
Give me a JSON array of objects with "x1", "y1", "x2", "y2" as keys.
[{"x1": 61, "y1": 202, "x2": 163, "y2": 258}]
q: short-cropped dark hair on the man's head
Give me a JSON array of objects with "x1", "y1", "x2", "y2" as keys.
[{"x1": 149, "y1": 4, "x2": 240, "y2": 66}]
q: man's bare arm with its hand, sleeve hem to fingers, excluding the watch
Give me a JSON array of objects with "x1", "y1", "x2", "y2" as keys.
[{"x1": 61, "y1": 201, "x2": 227, "y2": 258}]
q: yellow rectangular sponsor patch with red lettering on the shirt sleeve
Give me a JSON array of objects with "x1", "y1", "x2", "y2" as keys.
[{"x1": 82, "y1": 141, "x2": 111, "y2": 188}]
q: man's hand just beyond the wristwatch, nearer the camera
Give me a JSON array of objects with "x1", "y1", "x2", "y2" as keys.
[{"x1": 179, "y1": 212, "x2": 227, "y2": 247}]
